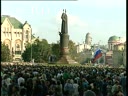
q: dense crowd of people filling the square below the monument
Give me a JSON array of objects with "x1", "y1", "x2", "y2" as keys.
[{"x1": 1, "y1": 65, "x2": 127, "y2": 96}]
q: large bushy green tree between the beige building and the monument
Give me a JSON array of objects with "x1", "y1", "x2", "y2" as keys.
[{"x1": 22, "y1": 38, "x2": 51, "y2": 63}]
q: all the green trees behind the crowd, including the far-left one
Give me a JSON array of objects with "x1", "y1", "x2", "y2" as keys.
[{"x1": 1, "y1": 38, "x2": 103, "y2": 63}]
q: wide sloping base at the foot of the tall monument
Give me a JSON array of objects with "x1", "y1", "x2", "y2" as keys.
[{"x1": 57, "y1": 55, "x2": 78, "y2": 64}]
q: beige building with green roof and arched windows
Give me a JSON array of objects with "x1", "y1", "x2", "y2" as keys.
[{"x1": 1, "y1": 15, "x2": 32, "y2": 60}]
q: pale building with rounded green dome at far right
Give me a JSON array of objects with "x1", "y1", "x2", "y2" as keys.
[{"x1": 106, "y1": 36, "x2": 126, "y2": 67}]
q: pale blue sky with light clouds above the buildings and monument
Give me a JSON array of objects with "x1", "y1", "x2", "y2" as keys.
[{"x1": 1, "y1": 0, "x2": 126, "y2": 45}]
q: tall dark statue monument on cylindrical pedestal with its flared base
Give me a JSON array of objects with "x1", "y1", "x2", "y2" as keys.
[{"x1": 57, "y1": 10, "x2": 76, "y2": 64}]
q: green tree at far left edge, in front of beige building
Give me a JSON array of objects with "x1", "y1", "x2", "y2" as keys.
[{"x1": 1, "y1": 43, "x2": 12, "y2": 62}]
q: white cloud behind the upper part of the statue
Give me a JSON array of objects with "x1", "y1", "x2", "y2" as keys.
[{"x1": 56, "y1": 11, "x2": 88, "y2": 28}]
